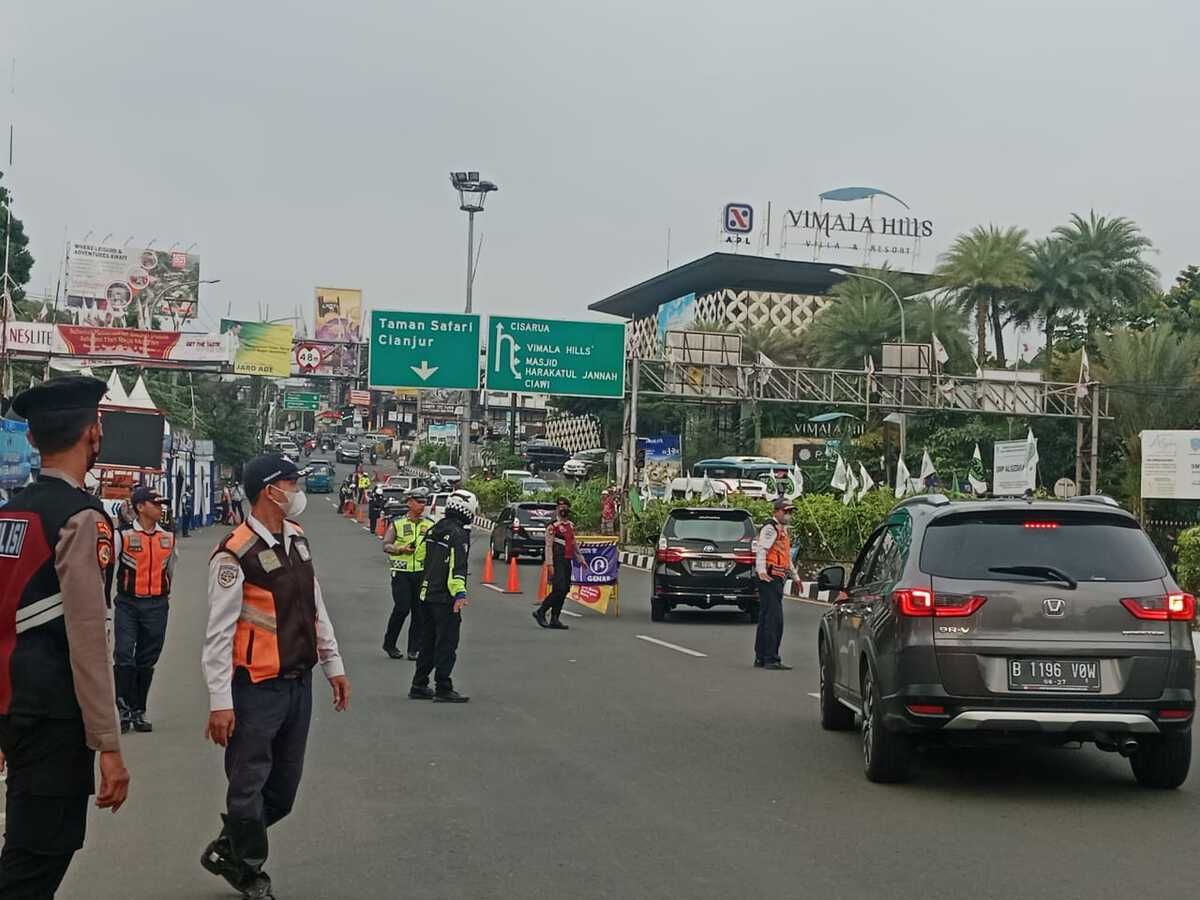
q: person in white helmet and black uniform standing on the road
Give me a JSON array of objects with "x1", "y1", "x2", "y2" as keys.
[{"x1": 408, "y1": 491, "x2": 475, "y2": 703}]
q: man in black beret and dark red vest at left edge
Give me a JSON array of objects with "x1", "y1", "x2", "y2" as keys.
[{"x1": 0, "y1": 376, "x2": 130, "y2": 900}]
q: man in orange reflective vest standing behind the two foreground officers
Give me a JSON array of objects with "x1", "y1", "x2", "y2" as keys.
[{"x1": 113, "y1": 487, "x2": 175, "y2": 734}]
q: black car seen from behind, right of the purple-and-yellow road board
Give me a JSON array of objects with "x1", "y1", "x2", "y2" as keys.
[{"x1": 650, "y1": 506, "x2": 758, "y2": 622}]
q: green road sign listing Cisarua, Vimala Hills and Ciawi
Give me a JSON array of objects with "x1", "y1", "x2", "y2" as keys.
[{"x1": 487, "y1": 316, "x2": 625, "y2": 397}]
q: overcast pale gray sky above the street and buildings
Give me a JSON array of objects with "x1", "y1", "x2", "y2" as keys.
[{"x1": 0, "y1": 0, "x2": 1200, "y2": 325}]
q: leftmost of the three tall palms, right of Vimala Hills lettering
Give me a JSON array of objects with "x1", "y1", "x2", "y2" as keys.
[{"x1": 934, "y1": 226, "x2": 1028, "y2": 366}]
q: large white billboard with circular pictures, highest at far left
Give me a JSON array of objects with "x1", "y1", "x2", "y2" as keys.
[{"x1": 66, "y1": 244, "x2": 200, "y2": 325}]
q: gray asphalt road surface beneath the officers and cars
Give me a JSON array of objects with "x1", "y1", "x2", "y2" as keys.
[{"x1": 60, "y1": 460, "x2": 1200, "y2": 900}]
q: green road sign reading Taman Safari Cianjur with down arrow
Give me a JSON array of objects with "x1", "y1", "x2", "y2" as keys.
[{"x1": 368, "y1": 310, "x2": 480, "y2": 390}]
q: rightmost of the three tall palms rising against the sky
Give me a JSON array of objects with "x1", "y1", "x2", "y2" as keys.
[{"x1": 1055, "y1": 210, "x2": 1159, "y2": 337}]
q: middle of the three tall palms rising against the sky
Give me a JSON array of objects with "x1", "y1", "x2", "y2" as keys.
[{"x1": 1008, "y1": 238, "x2": 1099, "y2": 370}]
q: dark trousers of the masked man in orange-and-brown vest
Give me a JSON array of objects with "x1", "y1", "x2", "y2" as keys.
[{"x1": 224, "y1": 668, "x2": 312, "y2": 870}]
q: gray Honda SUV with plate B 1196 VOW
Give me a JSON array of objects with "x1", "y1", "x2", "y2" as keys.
[{"x1": 817, "y1": 494, "x2": 1195, "y2": 787}]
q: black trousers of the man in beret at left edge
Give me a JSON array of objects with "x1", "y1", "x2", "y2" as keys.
[{"x1": 0, "y1": 715, "x2": 95, "y2": 900}]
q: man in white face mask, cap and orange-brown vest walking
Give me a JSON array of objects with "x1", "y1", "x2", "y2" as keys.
[{"x1": 200, "y1": 455, "x2": 350, "y2": 898}]
